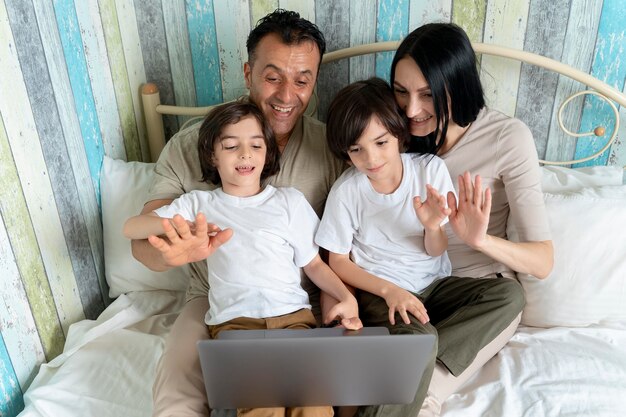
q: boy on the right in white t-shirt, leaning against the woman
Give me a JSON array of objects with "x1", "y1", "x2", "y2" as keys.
[{"x1": 315, "y1": 78, "x2": 454, "y2": 412}]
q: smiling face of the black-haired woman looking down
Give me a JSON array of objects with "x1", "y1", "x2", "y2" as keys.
[{"x1": 393, "y1": 57, "x2": 437, "y2": 136}]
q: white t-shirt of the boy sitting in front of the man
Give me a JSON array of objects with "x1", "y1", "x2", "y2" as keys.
[{"x1": 155, "y1": 185, "x2": 319, "y2": 324}]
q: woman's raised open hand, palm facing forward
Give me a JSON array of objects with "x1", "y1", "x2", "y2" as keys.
[{"x1": 448, "y1": 171, "x2": 491, "y2": 250}]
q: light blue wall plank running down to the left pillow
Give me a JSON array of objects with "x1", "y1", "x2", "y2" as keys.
[{"x1": 53, "y1": 0, "x2": 104, "y2": 204}]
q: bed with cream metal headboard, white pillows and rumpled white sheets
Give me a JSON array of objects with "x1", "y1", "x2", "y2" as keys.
[{"x1": 20, "y1": 42, "x2": 626, "y2": 417}]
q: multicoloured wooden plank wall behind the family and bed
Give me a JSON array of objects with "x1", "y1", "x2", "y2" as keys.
[{"x1": 0, "y1": 0, "x2": 626, "y2": 416}]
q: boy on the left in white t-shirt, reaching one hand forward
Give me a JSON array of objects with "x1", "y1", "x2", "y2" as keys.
[{"x1": 124, "y1": 101, "x2": 361, "y2": 416}]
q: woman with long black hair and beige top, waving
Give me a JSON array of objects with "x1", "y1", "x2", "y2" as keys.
[{"x1": 363, "y1": 24, "x2": 553, "y2": 416}]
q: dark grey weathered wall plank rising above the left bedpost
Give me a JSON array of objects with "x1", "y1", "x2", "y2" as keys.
[{"x1": 134, "y1": 0, "x2": 179, "y2": 140}]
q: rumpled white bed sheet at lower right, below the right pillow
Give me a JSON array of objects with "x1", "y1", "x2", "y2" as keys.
[{"x1": 442, "y1": 323, "x2": 626, "y2": 417}]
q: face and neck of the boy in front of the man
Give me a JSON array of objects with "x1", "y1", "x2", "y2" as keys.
[{"x1": 212, "y1": 116, "x2": 267, "y2": 197}]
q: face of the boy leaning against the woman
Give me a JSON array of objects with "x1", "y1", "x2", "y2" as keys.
[{"x1": 348, "y1": 116, "x2": 402, "y2": 194}]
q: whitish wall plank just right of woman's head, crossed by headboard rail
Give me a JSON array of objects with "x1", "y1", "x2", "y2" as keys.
[{"x1": 481, "y1": 0, "x2": 530, "y2": 116}]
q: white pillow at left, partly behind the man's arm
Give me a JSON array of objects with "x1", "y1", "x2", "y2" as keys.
[{"x1": 100, "y1": 156, "x2": 189, "y2": 298}]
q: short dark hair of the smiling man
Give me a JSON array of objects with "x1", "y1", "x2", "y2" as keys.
[{"x1": 246, "y1": 9, "x2": 326, "y2": 65}]
